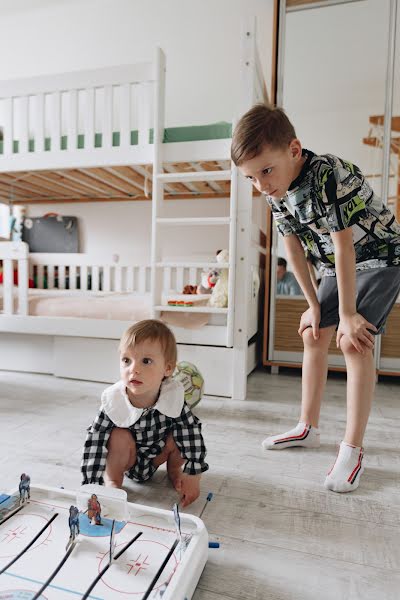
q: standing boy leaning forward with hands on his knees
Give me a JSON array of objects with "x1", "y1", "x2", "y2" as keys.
[{"x1": 231, "y1": 104, "x2": 400, "y2": 492}]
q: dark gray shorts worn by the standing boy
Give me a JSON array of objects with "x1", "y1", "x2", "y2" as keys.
[{"x1": 317, "y1": 267, "x2": 400, "y2": 333}]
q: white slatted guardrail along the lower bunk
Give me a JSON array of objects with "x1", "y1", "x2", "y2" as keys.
[{"x1": 0, "y1": 242, "x2": 217, "y2": 316}]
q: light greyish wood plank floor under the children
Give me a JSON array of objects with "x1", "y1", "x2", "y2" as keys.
[{"x1": 0, "y1": 371, "x2": 400, "y2": 600}]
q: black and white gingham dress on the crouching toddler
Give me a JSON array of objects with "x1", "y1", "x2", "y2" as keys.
[{"x1": 81, "y1": 382, "x2": 208, "y2": 484}]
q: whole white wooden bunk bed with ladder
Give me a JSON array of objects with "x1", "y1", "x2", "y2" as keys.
[{"x1": 0, "y1": 23, "x2": 267, "y2": 399}]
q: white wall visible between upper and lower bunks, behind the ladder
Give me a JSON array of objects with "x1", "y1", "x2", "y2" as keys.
[{"x1": 27, "y1": 198, "x2": 229, "y2": 264}]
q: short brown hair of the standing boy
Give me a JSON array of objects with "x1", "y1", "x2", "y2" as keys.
[{"x1": 231, "y1": 104, "x2": 296, "y2": 167}]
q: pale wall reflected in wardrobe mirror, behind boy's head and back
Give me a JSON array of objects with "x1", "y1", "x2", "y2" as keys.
[{"x1": 284, "y1": 0, "x2": 389, "y2": 180}]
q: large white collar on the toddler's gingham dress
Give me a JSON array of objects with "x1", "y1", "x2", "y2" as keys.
[{"x1": 101, "y1": 378, "x2": 184, "y2": 427}]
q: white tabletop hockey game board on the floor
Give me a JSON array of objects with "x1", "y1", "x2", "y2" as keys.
[{"x1": 0, "y1": 485, "x2": 208, "y2": 600}]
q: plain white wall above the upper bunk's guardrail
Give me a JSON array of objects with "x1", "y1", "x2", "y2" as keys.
[{"x1": 0, "y1": 0, "x2": 273, "y2": 126}]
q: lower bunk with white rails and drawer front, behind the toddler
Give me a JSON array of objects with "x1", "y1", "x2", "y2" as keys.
[{"x1": 0, "y1": 242, "x2": 259, "y2": 397}]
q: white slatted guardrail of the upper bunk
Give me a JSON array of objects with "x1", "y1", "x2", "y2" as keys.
[{"x1": 0, "y1": 53, "x2": 163, "y2": 171}]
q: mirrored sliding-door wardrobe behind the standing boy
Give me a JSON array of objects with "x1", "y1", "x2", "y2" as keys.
[{"x1": 264, "y1": 0, "x2": 400, "y2": 375}]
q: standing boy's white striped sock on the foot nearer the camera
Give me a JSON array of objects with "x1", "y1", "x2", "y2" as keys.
[{"x1": 324, "y1": 442, "x2": 364, "y2": 492}]
